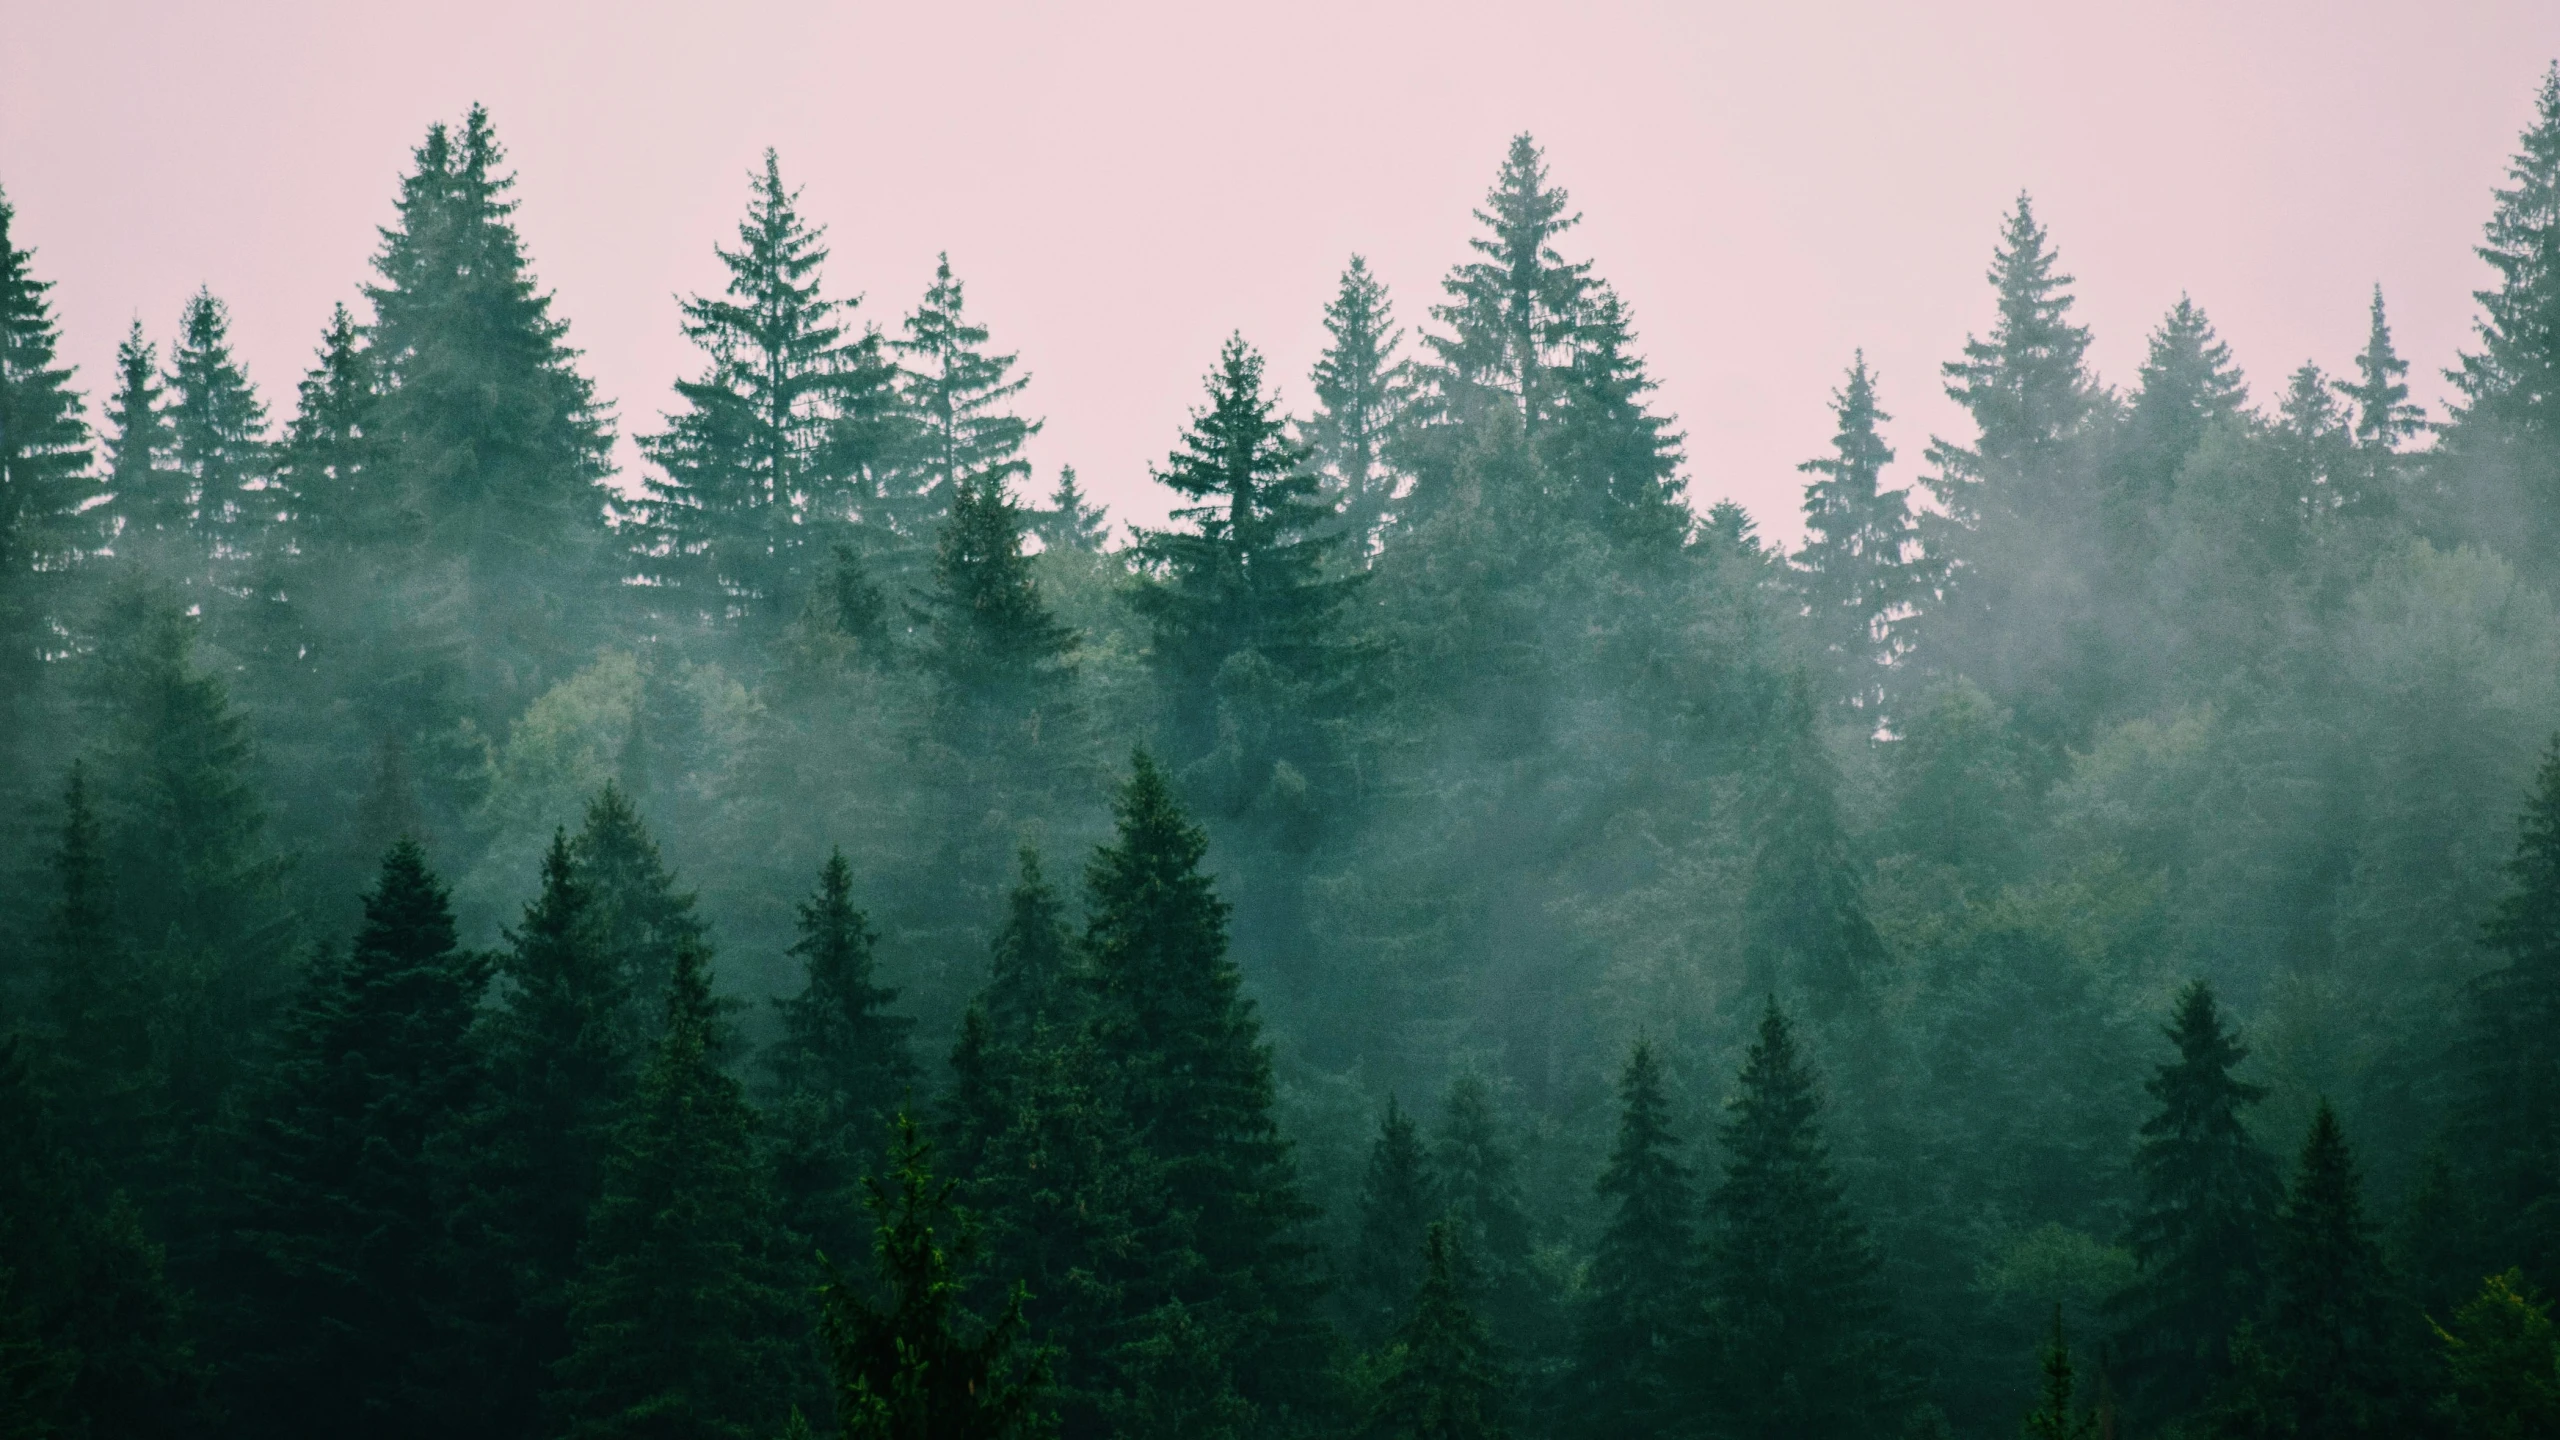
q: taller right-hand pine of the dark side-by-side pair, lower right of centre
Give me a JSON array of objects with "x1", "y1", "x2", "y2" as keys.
[{"x1": 1700, "y1": 1002, "x2": 1902, "y2": 1440}]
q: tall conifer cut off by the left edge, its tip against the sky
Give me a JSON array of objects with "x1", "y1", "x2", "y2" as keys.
[{"x1": 0, "y1": 195, "x2": 95, "y2": 727}]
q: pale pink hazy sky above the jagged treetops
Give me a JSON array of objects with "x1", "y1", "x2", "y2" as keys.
[{"x1": 0, "y1": 0, "x2": 2560, "y2": 538}]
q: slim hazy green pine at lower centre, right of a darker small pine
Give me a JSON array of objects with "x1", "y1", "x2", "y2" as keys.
[{"x1": 1431, "y1": 1074, "x2": 1559, "y2": 1361}]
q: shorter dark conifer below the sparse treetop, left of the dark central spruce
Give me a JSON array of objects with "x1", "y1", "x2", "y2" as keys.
[{"x1": 916, "y1": 474, "x2": 1075, "y2": 743}]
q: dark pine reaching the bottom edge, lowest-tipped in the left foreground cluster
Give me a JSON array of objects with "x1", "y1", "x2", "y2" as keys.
[{"x1": 550, "y1": 938, "x2": 799, "y2": 1437}]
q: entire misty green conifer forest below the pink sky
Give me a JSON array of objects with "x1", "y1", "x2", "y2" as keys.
[{"x1": 0, "y1": 67, "x2": 2560, "y2": 1440}]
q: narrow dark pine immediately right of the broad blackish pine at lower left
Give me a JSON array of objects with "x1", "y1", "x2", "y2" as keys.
[{"x1": 456, "y1": 830, "x2": 637, "y2": 1435}]
